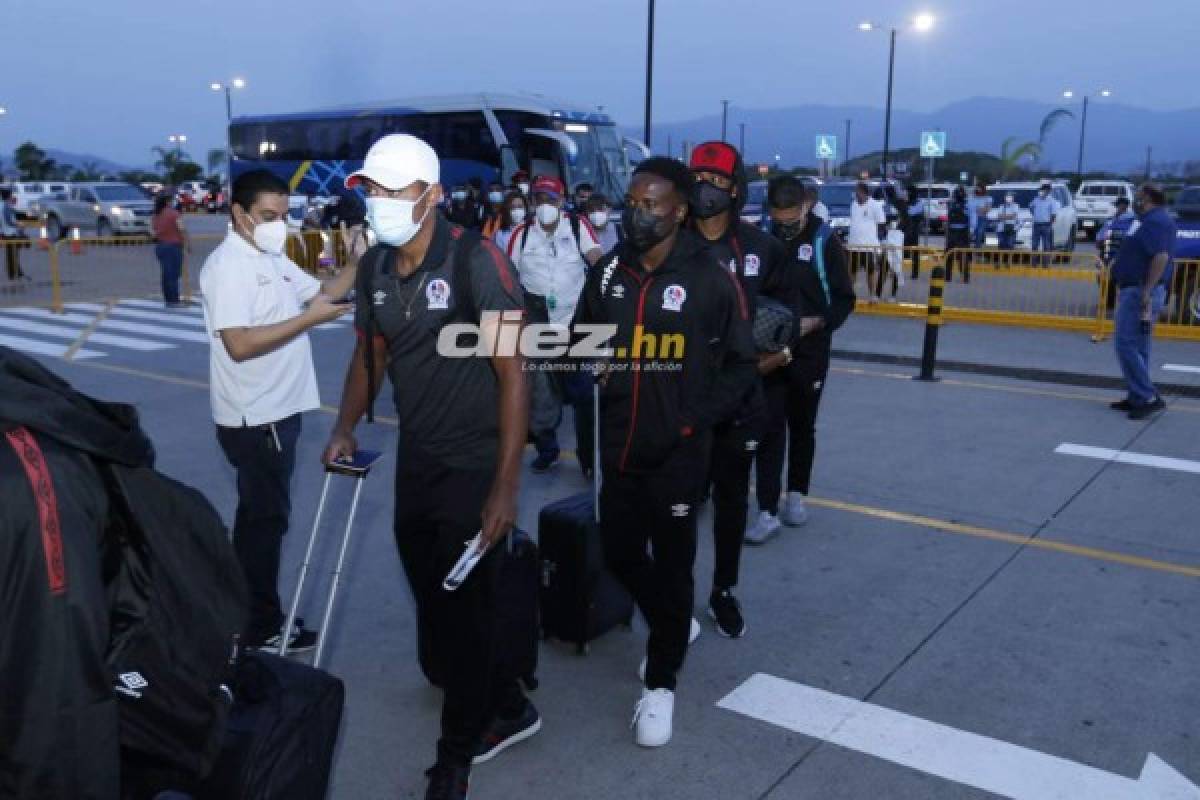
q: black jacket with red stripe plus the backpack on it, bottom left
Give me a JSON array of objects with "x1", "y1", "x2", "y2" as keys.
[{"x1": 0, "y1": 347, "x2": 246, "y2": 800}]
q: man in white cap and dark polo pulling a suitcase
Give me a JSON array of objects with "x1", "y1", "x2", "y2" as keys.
[{"x1": 324, "y1": 133, "x2": 541, "y2": 800}]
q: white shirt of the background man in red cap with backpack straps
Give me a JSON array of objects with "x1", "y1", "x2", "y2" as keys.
[{"x1": 509, "y1": 211, "x2": 600, "y2": 325}]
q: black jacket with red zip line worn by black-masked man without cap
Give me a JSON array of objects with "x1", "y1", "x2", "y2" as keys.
[{"x1": 575, "y1": 230, "x2": 757, "y2": 473}]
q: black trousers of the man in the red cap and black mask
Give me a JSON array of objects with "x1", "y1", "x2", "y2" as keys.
[{"x1": 709, "y1": 420, "x2": 761, "y2": 593}]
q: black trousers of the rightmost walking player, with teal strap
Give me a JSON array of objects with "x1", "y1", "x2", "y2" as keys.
[{"x1": 757, "y1": 339, "x2": 829, "y2": 513}]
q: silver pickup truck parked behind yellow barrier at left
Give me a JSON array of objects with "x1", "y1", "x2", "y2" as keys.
[{"x1": 42, "y1": 182, "x2": 154, "y2": 240}]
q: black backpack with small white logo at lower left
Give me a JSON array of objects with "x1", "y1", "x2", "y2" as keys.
[{"x1": 96, "y1": 461, "x2": 248, "y2": 778}]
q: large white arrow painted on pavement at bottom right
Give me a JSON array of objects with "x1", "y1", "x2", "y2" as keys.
[{"x1": 716, "y1": 673, "x2": 1200, "y2": 800}]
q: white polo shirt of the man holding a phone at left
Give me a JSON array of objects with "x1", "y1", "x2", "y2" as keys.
[{"x1": 199, "y1": 233, "x2": 320, "y2": 428}]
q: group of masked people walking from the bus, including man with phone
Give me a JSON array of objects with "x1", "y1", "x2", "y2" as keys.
[{"x1": 189, "y1": 134, "x2": 854, "y2": 800}]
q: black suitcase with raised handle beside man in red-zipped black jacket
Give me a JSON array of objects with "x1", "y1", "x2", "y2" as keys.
[{"x1": 538, "y1": 385, "x2": 634, "y2": 655}]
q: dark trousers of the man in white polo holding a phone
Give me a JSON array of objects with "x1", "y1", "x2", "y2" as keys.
[{"x1": 217, "y1": 414, "x2": 302, "y2": 642}]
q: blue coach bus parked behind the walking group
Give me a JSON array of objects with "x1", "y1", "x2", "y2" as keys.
[{"x1": 229, "y1": 94, "x2": 647, "y2": 205}]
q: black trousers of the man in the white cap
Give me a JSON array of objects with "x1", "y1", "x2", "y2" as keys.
[{"x1": 395, "y1": 450, "x2": 524, "y2": 766}]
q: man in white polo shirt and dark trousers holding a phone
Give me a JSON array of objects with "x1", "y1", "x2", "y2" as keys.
[{"x1": 200, "y1": 169, "x2": 356, "y2": 650}]
